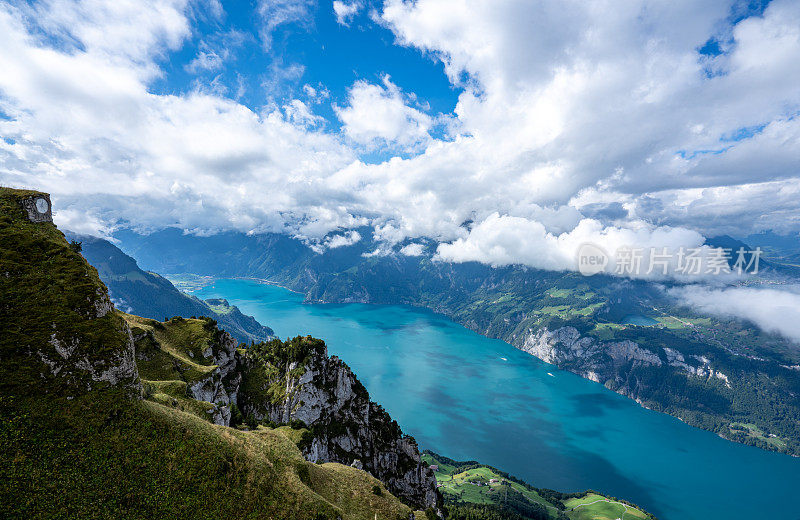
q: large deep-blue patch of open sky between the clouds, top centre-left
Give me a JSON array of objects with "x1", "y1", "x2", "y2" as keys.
[{"x1": 152, "y1": 1, "x2": 461, "y2": 140}]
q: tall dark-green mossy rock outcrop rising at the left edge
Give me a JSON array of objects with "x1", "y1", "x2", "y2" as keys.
[{"x1": 0, "y1": 188, "x2": 140, "y2": 396}]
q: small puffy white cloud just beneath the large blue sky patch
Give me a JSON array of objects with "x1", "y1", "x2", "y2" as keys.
[{"x1": 335, "y1": 76, "x2": 433, "y2": 148}]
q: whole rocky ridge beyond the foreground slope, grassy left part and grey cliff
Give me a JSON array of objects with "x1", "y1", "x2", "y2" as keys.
[{"x1": 126, "y1": 316, "x2": 439, "y2": 509}]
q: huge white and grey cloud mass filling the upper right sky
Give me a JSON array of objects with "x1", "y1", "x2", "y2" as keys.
[{"x1": 382, "y1": 0, "x2": 800, "y2": 233}]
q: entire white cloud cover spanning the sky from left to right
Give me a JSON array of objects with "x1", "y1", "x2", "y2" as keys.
[{"x1": 0, "y1": 0, "x2": 800, "y2": 276}]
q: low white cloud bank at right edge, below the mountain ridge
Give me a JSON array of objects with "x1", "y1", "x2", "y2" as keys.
[{"x1": 670, "y1": 285, "x2": 800, "y2": 343}]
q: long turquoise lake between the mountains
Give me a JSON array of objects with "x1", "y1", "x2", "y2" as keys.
[{"x1": 193, "y1": 280, "x2": 800, "y2": 520}]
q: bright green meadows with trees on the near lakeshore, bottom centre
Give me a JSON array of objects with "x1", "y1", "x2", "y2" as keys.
[{"x1": 422, "y1": 452, "x2": 652, "y2": 520}]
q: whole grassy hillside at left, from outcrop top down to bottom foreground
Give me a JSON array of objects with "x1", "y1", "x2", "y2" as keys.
[{"x1": 0, "y1": 189, "x2": 411, "y2": 520}]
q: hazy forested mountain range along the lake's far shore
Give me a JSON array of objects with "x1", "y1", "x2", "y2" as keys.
[{"x1": 115, "y1": 229, "x2": 800, "y2": 455}]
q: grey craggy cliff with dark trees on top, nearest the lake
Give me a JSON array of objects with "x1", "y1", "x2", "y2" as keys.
[{"x1": 239, "y1": 337, "x2": 439, "y2": 508}]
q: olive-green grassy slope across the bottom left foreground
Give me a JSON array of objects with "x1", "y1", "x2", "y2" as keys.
[{"x1": 0, "y1": 393, "x2": 410, "y2": 519}]
